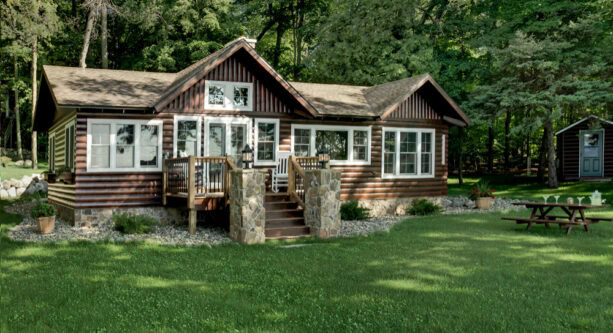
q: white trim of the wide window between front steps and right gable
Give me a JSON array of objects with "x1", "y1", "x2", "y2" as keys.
[{"x1": 290, "y1": 124, "x2": 372, "y2": 165}]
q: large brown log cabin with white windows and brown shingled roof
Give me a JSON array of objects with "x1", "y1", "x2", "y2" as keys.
[{"x1": 34, "y1": 37, "x2": 469, "y2": 233}]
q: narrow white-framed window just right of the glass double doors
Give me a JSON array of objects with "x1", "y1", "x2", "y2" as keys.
[{"x1": 253, "y1": 118, "x2": 279, "y2": 165}]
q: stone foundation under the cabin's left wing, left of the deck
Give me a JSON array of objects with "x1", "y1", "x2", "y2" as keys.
[{"x1": 54, "y1": 204, "x2": 185, "y2": 227}]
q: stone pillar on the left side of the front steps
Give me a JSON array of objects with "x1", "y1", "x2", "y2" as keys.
[{"x1": 230, "y1": 169, "x2": 266, "y2": 244}]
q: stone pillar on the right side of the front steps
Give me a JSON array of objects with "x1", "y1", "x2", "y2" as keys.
[{"x1": 304, "y1": 169, "x2": 341, "y2": 238}]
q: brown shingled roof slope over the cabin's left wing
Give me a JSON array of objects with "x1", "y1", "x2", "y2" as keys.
[{"x1": 43, "y1": 65, "x2": 176, "y2": 108}]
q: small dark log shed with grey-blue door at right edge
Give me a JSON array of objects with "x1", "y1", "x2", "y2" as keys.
[{"x1": 556, "y1": 115, "x2": 613, "y2": 180}]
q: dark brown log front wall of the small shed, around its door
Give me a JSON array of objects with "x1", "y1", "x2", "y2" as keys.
[{"x1": 557, "y1": 121, "x2": 613, "y2": 180}]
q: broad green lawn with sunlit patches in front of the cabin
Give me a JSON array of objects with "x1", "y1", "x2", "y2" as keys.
[{"x1": 0, "y1": 195, "x2": 613, "y2": 332}]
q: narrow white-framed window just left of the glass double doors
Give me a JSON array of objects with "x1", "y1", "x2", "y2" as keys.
[{"x1": 173, "y1": 116, "x2": 202, "y2": 157}]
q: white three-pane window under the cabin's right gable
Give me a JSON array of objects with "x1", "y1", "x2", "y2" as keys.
[{"x1": 381, "y1": 127, "x2": 436, "y2": 178}]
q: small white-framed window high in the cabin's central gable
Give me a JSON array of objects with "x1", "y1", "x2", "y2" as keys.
[{"x1": 204, "y1": 80, "x2": 253, "y2": 111}]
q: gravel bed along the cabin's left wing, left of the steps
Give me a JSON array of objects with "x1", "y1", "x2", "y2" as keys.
[{"x1": 5, "y1": 201, "x2": 231, "y2": 246}]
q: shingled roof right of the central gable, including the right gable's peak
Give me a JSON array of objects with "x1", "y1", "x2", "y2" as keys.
[{"x1": 291, "y1": 74, "x2": 470, "y2": 125}]
